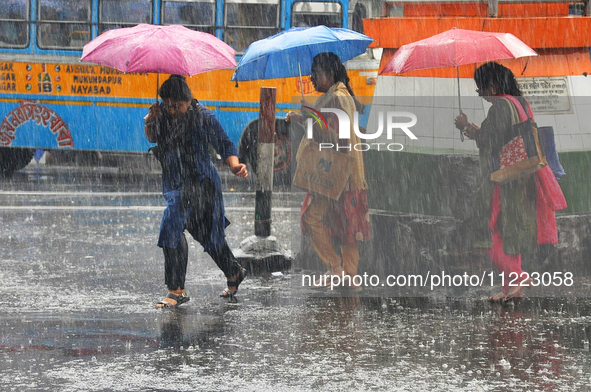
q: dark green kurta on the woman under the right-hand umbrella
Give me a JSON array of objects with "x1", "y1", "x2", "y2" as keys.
[{"x1": 471, "y1": 98, "x2": 537, "y2": 254}]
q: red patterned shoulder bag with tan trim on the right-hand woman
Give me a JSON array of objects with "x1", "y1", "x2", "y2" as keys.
[{"x1": 490, "y1": 95, "x2": 548, "y2": 184}]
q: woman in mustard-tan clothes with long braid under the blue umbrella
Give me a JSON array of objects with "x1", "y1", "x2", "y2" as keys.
[{"x1": 285, "y1": 52, "x2": 369, "y2": 286}]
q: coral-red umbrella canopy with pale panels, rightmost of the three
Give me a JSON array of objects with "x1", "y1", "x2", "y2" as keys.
[{"x1": 380, "y1": 28, "x2": 538, "y2": 74}]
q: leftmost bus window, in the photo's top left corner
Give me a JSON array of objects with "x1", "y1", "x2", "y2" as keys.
[{"x1": 0, "y1": 0, "x2": 29, "y2": 48}]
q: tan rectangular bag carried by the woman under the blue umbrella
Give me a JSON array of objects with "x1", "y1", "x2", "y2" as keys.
[{"x1": 293, "y1": 138, "x2": 355, "y2": 200}]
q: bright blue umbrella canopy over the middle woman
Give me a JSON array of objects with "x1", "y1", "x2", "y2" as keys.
[{"x1": 232, "y1": 26, "x2": 373, "y2": 81}]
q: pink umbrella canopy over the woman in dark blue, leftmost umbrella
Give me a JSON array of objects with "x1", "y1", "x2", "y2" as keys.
[{"x1": 80, "y1": 24, "x2": 236, "y2": 76}]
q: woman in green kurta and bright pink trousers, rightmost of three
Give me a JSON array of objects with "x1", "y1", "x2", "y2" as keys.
[{"x1": 455, "y1": 62, "x2": 566, "y2": 302}]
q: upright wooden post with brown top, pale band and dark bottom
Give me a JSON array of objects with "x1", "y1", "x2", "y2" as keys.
[{"x1": 254, "y1": 87, "x2": 277, "y2": 237}]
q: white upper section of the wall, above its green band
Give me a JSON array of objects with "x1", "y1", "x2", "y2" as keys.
[{"x1": 367, "y1": 75, "x2": 591, "y2": 153}]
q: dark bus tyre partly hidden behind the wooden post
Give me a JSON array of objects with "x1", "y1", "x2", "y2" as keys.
[{"x1": 239, "y1": 118, "x2": 304, "y2": 186}]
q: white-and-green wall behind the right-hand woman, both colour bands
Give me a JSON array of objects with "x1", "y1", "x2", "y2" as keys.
[{"x1": 365, "y1": 76, "x2": 591, "y2": 214}]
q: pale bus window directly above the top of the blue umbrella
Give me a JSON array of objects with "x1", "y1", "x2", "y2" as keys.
[{"x1": 291, "y1": 1, "x2": 343, "y2": 27}]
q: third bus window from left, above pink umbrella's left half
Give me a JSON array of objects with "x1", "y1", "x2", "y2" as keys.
[{"x1": 99, "y1": 0, "x2": 152, "y2": 34}]
